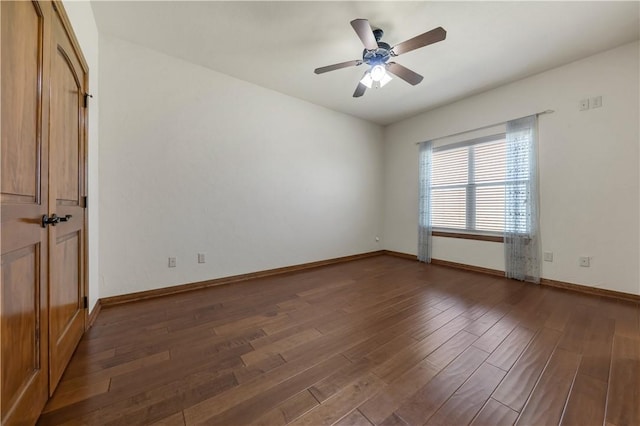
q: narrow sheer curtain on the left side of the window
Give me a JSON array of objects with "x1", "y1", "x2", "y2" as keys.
[{"x1": 418, "y1": 141, "x2": 433, "y2": 263}]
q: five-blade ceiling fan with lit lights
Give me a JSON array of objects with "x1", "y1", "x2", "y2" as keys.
[{"x1": 314, "y1": 19, "x2": 447, "y2": 98}]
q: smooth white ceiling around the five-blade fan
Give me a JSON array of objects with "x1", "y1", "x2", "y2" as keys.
[{"x1": 92, "y1": 0, "x2": 640, "y2": 125}]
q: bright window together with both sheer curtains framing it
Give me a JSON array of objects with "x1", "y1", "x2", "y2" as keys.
[{"x1": 418, "y1": 115, "x2": 540, "y2": 283}]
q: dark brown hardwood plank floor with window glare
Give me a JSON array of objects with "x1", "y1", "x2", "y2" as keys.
[{"x1": 39, "y1": 255, "x2": 640, "y2": 426}]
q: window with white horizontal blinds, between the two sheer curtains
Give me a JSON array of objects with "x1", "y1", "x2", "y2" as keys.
[{"x1": 431, "y1": 134, "x2": 506, "y2": 235}]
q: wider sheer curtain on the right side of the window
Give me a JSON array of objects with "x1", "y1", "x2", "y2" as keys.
[{"x1": 504, "y1": 115, "x2": 540, "y2": 283}]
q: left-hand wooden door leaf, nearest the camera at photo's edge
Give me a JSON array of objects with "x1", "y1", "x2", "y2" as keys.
[{"x1": 0, "y1": 1, "x2": 50, "y2": 425}]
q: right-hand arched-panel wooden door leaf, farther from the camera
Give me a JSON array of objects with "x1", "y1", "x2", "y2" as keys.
[{"x1": 48, "y1": 1, "x2": 86, "y2": 394}]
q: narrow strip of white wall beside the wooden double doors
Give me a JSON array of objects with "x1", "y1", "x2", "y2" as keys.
[{"x1": 63, "y1": 0, "x2": 100, "y2": 310}]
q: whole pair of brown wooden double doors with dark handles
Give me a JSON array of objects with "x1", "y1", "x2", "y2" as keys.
[{"x1": 0, "y1": 1, "x2": 88, "y2": 425}]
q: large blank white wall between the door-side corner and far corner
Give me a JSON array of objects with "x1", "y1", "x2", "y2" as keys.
[{"x1": 99, "y1": 34, "x2": 383, "y2": 297}]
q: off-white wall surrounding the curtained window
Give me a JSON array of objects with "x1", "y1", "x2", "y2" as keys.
[{"x1": 384, "y1": 42, "x2": 640, "y2": 294}]
